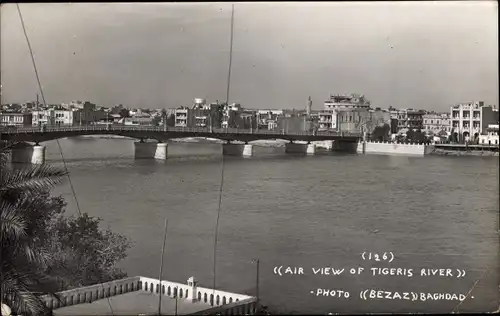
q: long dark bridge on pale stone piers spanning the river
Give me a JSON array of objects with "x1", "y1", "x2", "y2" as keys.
[{"x1": 0, "y1": 125, "x2": 360, "y2": 163}]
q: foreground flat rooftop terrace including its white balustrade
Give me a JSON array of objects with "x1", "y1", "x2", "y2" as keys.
[{"x1": 30, "y1": 276, "x2": 258, "y2": 316}]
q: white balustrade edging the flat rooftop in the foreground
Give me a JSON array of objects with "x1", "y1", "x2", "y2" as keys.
[{"x1": 42, "y1": 276, "x2": 256, "y2": 315}]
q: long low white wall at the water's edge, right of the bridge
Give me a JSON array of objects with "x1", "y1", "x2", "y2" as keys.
[{"x1": 356, "y1": 142, "x2": 429, "y2": 156}]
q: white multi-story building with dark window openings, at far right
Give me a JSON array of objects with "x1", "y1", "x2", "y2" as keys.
[{"x1": 450, "y1": 101, "x2": 498, "y2": 139}]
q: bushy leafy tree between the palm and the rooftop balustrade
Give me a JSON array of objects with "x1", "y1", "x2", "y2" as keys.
[{"x1": 43, "y1": 197, "x2": 130, "y2": 290}]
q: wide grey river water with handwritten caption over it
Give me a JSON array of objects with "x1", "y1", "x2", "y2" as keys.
[{"x1": 45, "y1": 138, "x2": 500, "y2": 314}]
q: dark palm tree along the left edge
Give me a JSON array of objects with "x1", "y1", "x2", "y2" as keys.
[{"x1": 0, "y1": 144, "x2": 66, "y2": 315}]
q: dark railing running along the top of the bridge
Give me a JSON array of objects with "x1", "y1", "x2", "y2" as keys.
[{"x1": 0, "y1": 124, "x2": 360, "y2": 137}]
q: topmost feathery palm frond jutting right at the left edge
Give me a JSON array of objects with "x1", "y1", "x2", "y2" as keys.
[{"x1": 0, "y1": 165, "x2": 67, "y2": 194}]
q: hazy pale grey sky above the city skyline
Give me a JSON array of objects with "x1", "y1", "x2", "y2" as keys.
[{"x1": 0, "y1": 1, "x2": 499, "y2": 111}]
